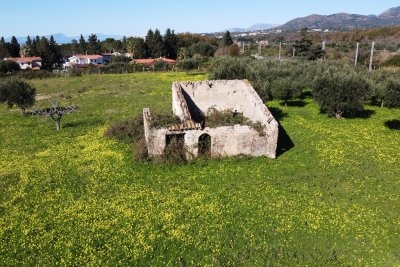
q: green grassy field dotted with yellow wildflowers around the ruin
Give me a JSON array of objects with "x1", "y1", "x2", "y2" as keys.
[{"x1": 0, "y1": 73, "x2": 400, "y2": 266}]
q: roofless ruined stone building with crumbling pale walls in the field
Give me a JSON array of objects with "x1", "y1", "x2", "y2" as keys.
[{"x1": 143, "y1": 80, "x2": 278, "y2": 159}]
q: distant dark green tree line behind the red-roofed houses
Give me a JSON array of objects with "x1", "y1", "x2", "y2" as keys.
[{"x1": 0, "y1": 29, "x2": 239, "y2": 69}]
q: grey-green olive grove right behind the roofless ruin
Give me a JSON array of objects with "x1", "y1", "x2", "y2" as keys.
[{"x1": 210, "y1": 58, "x2": 400, "y2": 118}]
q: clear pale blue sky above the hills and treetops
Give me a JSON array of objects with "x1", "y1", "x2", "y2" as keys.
[{"x1": 0, "y1": 0, "x2": 400, "y2": 38}]
